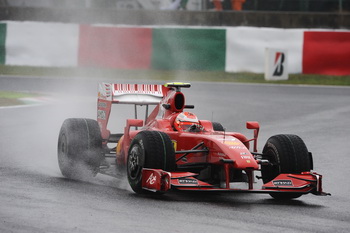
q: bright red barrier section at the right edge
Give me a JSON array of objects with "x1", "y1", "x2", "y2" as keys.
[{"x1": 303, "y1": 31, "x2": 350, "y2": 75}]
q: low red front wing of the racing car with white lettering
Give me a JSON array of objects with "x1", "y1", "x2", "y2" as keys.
[{"x1": 142, "y1": 168, "x2": 330, "y2": 196}]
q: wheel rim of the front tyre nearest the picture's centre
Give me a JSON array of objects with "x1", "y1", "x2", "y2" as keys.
[{"x1": 128, "y1": 145, "x2": 143, "y2": 179}]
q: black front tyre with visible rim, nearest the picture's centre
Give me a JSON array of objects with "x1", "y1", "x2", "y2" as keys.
[{"x1": 126, "y1": 131, "x2": 176, "y2": 193}]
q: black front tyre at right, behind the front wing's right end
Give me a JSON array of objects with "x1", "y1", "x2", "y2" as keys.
[{"x1": 261, "y1": 134, "x2": 312, "y2": 199}]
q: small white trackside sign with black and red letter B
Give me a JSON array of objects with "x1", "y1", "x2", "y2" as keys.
[{"x1": 265, "y1": 48, "x2": 288, "y2": 80}]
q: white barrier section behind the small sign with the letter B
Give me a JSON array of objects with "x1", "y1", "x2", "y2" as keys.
[{"x1": 225, "y1": 27, "x2": 305, "y2": 73}]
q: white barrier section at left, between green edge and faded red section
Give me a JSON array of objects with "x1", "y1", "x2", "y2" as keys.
[{"x1": 5, "y1": 22, "x2": 79, "y2": 67}]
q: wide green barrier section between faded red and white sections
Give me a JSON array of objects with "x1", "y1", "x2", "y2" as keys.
[{"x1": 152, "y1": 28, "x2": 226, "y2": 70}]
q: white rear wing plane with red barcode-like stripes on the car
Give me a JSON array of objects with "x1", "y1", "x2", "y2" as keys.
[{"x1": 98, "y1": 83, "x2": 168, "y2": 105}]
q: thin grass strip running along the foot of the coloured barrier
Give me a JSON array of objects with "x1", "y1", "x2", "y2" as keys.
[{"x1": 0, "y1": 65, "x2": 350, "y2": 86}]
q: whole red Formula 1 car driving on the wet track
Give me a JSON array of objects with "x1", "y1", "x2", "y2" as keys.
[{"x1": 58, "y1": 83, "x2": 327, "y2": 199}]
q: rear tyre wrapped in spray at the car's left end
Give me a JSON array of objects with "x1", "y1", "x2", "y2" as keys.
[{"x1": 57, "y1": 118, "x2": 103, "y2": 180}]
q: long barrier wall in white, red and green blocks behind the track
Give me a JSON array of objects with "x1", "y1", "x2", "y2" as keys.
[{"x1": 0, "y1": 21, "x2": 350, "y2": 75}]
